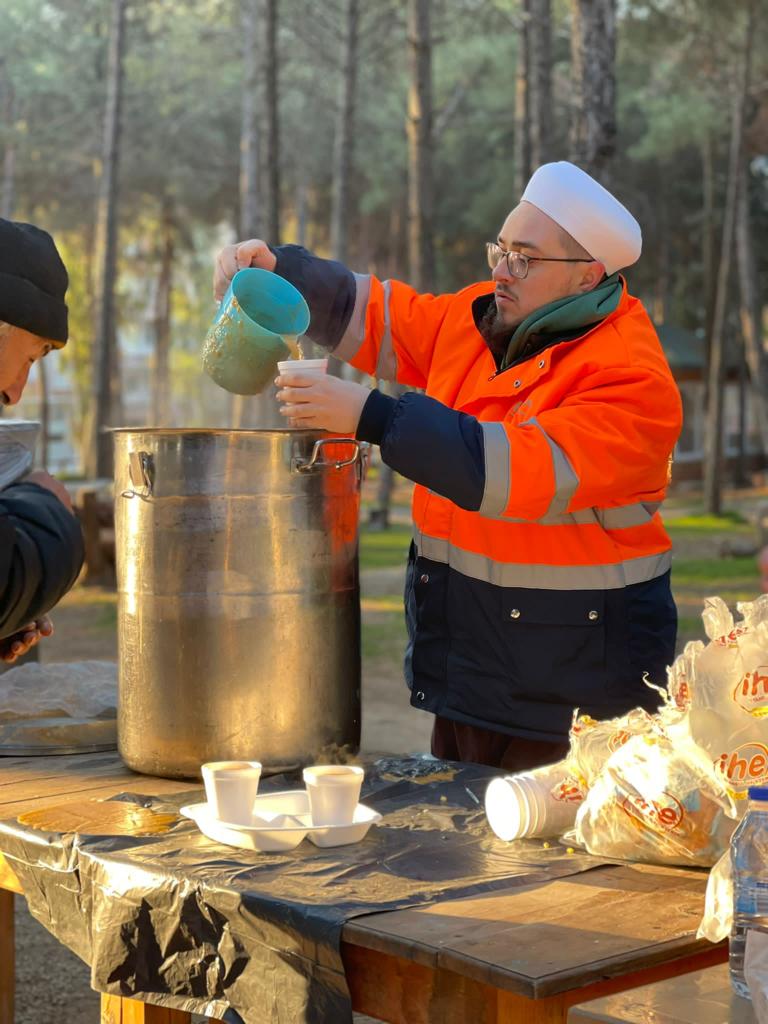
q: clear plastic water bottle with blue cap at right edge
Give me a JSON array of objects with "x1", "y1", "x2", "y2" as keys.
[{"x1": 728, "y1": 786, "x2": 768, "y2": 999}]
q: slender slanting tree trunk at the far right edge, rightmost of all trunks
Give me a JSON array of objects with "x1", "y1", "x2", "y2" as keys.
[{"x1": 736, "y1": 159, "x2": 768, "y2": 454}]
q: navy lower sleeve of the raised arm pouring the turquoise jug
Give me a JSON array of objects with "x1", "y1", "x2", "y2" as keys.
[{"x1": 271, "y1": 246, "x2": 357, "y2": 351}]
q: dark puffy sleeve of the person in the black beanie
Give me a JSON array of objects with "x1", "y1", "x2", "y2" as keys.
[{"x1": 0, "y1": 482, "x2": 83, "y2": 638}]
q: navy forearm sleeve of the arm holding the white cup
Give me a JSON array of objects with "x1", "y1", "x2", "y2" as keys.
[{"x1": 357, "y1": 390, "x2": 485, "y2": 512}]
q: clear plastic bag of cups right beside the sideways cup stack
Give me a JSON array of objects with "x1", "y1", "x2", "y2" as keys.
[{"x1": 574, "y1": 723, "x2": 736, "y2": 867}]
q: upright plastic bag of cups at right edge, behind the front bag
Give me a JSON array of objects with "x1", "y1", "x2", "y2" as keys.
[{"x1": 670, "y1": 595, "x2": 768, "y2": 816}]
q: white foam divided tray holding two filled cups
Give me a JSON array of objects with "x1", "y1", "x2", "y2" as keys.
[{"x1": 181, "y1": 790, "x2": 381, "y2": 853}]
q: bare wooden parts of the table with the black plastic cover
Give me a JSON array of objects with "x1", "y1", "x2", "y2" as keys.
[{"x1": 0, "y1": 755, "x2": 727, "y2": 1024}]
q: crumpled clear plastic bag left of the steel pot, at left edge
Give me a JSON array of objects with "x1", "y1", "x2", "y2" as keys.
[{"x1": 0, "y1": 662, "x2": 118, "y2": 722}]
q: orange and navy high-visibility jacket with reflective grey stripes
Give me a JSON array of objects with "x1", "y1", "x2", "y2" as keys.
[{"x1": 275, "y1": 247, "x2": 682, "y2": 739}]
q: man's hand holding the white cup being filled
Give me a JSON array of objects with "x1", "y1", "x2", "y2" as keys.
[{"x1": 274, "y1": 370, "x2": 371, "y2": 434}]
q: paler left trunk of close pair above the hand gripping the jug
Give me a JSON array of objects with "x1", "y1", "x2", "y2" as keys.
[{"x1": 239, "y1": 0, "x2": 263, "y2": 239}]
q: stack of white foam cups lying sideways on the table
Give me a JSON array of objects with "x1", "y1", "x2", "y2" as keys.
[{"x1": 485, "y1": 761, "x2": 582, "y2": 841}]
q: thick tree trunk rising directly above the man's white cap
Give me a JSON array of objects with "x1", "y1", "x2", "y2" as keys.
[{"x1": 570, "y1": 0, "x2": 616, "y2": 185}]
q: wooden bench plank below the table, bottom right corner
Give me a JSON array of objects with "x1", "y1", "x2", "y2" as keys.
[{"x1": 568, "y1": 964, "x2": 756, "y2": 1024}]
